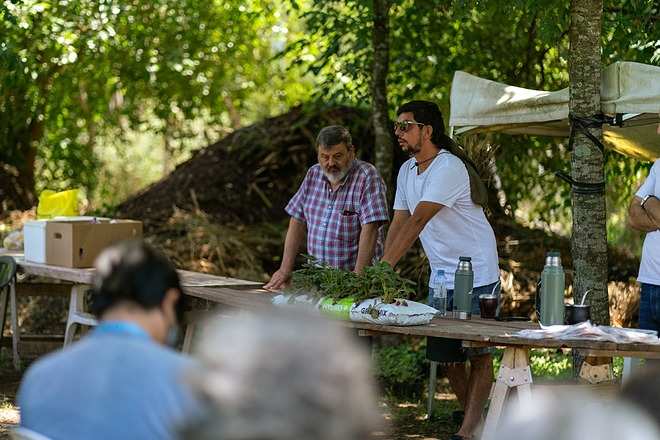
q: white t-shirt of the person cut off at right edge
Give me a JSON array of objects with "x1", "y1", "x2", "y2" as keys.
[{"x1": 635, "y1": 160, "x2": 660, "y2": 285}]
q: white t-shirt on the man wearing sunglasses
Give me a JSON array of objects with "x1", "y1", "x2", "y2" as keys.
[{"x1": 394, "y1": 150, "x2": 500, "y2": 289}]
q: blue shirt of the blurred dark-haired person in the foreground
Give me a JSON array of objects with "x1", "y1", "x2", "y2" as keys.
[{"x1": 18, "y1": 335, "x2": 198, "y2": 439}]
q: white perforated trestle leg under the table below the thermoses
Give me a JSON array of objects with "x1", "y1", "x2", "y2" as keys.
[{"x1": 482, "y1": 347, "x2": 532, "y2": 440}]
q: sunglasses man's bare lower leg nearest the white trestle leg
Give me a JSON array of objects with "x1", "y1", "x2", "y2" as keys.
[{"x1": 457, "y1": 354, "x2": 493, "y2": 438}]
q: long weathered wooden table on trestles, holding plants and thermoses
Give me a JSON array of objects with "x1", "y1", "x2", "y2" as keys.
[{"x1": 5, "y1": 259, "x2": 660, "y2": 440}]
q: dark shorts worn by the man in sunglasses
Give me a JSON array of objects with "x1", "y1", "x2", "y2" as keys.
[{"x1": 426, "y1": 282, "x2": 500, "y2": 364}]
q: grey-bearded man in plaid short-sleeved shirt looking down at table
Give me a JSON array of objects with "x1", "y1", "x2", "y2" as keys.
[{"x1": 264, "y1": 125, "x2": 389, "y2": 290}]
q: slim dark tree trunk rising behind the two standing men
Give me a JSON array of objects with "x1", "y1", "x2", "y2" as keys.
[{"x1": 371, "y1": 0, "x2": 394, "y2": 200}]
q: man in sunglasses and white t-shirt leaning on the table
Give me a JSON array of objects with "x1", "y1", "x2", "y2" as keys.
[{"x1": 383, "y1": 101, "x2": 499, "y2": 439}]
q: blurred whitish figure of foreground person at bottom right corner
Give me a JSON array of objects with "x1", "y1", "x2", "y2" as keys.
[{"x1": 495, "y1": 390, "x2": 660, "y2": 440}]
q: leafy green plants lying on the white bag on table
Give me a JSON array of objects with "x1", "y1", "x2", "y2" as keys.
[{"x1": 288, "y1": 255, "x2": 416, "y2": 305}]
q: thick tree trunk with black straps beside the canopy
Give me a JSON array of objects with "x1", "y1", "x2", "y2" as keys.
[{"x1": 569, "y1": 0, "x2": 610, "y2": 324}]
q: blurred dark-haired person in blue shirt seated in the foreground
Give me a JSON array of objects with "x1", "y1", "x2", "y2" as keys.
[{"x1": 18, "y1": 241, "x2": 197, "y2": 439}]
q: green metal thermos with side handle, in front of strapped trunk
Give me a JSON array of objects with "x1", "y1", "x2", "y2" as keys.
[{"x1": 537, "y1": 251, "x2": 566, "y2": 325}]
